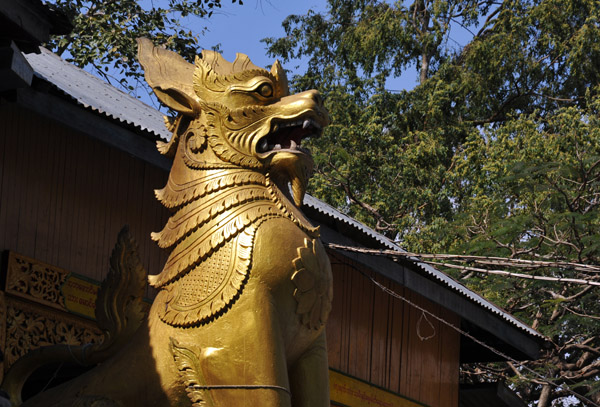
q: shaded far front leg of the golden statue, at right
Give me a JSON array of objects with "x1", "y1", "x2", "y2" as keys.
[{"x1": 289, "y1": 330, "x2": 331, "y2": 407}]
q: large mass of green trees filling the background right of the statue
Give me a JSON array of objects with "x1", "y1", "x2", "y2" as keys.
[{"x1": 265, "y1": 0, "x2": 600, "y2": 407}]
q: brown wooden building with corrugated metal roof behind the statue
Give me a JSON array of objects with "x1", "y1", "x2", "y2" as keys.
[{"x1": 0, "y1": 0, "x2": 544, "y2": 407}]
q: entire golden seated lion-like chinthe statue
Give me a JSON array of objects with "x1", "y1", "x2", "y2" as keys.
[{"x1": 7, "y1": 39, "x2": 332, "y2": 407}]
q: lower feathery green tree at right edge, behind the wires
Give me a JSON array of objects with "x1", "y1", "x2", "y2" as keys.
[{"x1": 453, "y1": 97, "x2": 600, "y2": 406}]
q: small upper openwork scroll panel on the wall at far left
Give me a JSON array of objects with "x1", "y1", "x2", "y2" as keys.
[{"x1": 6, "y1": 252, "x2": 69, "y2": 309}]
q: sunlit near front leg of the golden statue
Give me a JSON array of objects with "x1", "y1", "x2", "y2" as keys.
[{"x1": 171, "y1": 279, "x2": 291, "y2": 407}]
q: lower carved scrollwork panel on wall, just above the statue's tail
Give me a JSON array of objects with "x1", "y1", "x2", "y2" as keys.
[{"x1": 4, "y1": 296, "x2": 102, "y2": 371}]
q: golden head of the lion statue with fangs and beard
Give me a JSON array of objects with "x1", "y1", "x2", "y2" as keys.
[{"x1": 138, "y1": 39, "x2": 329, "y2": 205}]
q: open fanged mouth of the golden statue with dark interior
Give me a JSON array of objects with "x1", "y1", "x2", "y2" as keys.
[{"x1": 256, "y1": 118, "x2": 323, "y2": 155}]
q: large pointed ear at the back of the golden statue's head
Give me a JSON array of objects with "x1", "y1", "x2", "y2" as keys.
[{"x1": 137, "y1": 38, "x2": 200, "y2": 117}]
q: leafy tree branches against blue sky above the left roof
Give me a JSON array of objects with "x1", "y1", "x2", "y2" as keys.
[{"x1": 46, "y1": 0, "x2": 243, "y2": 98}]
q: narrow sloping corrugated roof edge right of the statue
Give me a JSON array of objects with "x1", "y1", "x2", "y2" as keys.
[{"x1": 304, "y1": 194, "x2": 545, "y2": 339}]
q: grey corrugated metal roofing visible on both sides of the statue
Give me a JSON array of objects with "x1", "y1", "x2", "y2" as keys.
[{"x1": 19, "y1": 48, "x2": 544, "y2": 338}]
